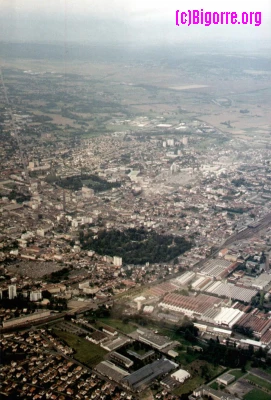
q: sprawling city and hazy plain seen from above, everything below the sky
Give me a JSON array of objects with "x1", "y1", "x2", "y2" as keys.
[{"x1": 0, "y1": 3, "x2": 271, "y2": 400}]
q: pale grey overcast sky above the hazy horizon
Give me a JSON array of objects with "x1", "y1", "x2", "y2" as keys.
[{"x1": 0, "y1": 0, "x2": 271, "y2": 44}]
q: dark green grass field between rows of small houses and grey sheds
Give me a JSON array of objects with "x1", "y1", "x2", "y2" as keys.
[{"x1": 54, "y1": 330, "x2": 107, "y2": 367}]
